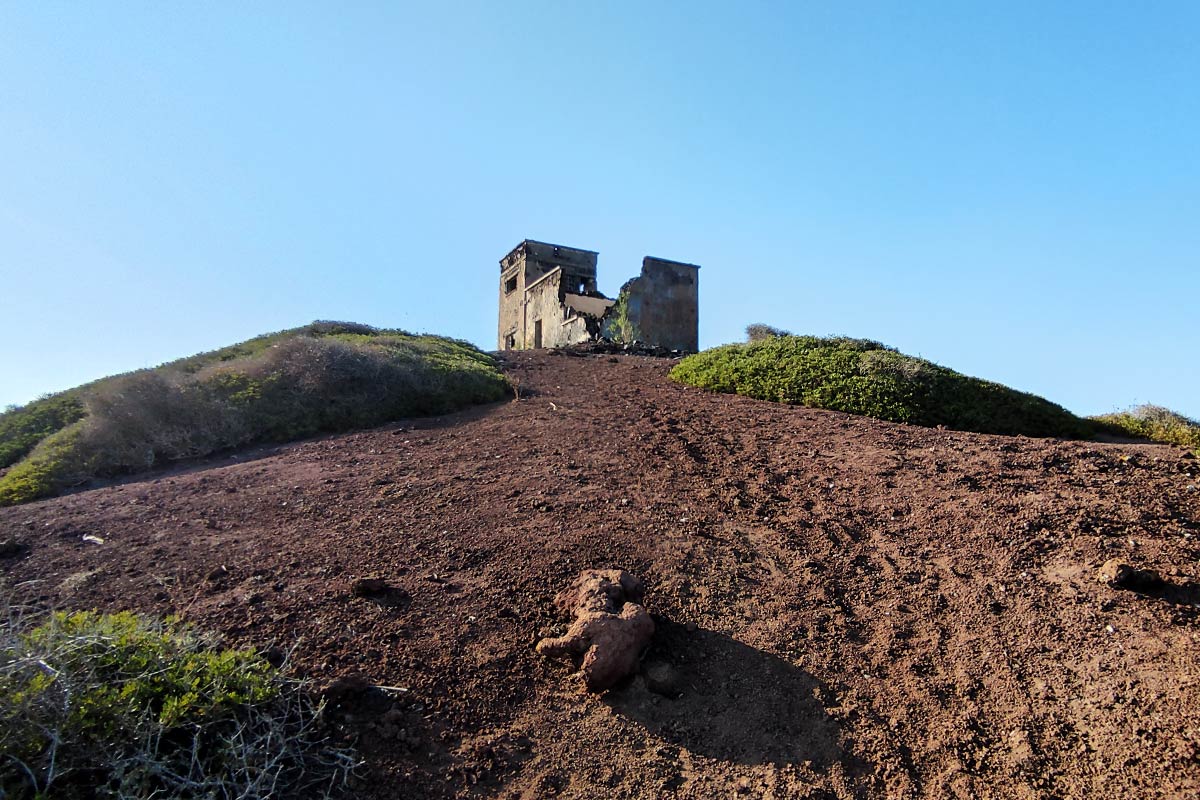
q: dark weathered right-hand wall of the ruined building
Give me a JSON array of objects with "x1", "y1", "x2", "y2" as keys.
[{"x1": 622, "y1": 255, "x2": 700, "y2": 351}]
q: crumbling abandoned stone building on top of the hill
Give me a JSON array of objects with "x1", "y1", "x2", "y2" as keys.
[{"x1": 498, "y1": 239, "x2": 700, "y2": 353}]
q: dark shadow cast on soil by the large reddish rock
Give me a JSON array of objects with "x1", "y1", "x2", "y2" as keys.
[{"x1": 605, "y1": 619, "x2": 856, "y2": 770}]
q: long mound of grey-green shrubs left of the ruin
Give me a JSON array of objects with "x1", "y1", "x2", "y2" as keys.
[{"x1": 0, "y1": 323, "x2": 508, "y2": 506}]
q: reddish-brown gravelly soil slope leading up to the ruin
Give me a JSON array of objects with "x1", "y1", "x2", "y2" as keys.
[{"x1": 0, "y1": 353, "x2": 1200, "y2": 799}]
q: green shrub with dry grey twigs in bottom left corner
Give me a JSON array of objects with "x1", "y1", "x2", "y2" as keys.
[{"x1": 0, "y1": 612, "x2": 356, "y2": 800}]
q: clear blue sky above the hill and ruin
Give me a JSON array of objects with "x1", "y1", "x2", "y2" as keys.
[{"x1": 0, "y1": 0, "x2": 1200, "y2": 417}]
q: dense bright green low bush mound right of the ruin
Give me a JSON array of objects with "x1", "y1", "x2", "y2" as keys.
[{"x1": 671, "y1": 335, "x2": 1092, "y2": 438}]
